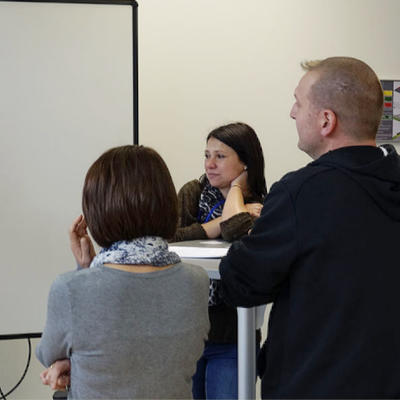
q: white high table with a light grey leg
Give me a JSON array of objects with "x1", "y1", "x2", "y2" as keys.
[{"x1": 169, "y1": 240, "x2": 265, "y2": 400}]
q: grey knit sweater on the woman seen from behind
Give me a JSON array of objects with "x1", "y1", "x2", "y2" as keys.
[{"x1": 36, "y1": 263, "x2": 209, "y2": 399}]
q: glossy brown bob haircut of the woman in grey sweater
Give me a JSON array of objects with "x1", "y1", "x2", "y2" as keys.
[{"x1": 82, "y1": 145, "x2": 178, "y2": 247}]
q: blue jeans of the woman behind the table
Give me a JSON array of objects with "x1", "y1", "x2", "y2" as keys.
[{"x1": 192, "y1": 343, "x2": 238, "y2": 400}]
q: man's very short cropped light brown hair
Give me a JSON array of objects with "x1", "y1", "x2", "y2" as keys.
[{"x1": 301, "y1": 57, "x2": 383, "y2": 139}]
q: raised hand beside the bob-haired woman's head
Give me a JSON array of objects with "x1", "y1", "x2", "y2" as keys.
[{"x1": 69, "y1": 215, "x2": 96, "y2": 268}]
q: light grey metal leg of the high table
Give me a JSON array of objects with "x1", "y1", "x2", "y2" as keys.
[{"x1": 237, "y1": 307, "x2": 256, "y2": 400}]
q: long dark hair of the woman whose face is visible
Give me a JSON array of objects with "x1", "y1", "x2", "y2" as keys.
[{"x1": 207, "y1": 122, "x2": 267, "y2": 199}]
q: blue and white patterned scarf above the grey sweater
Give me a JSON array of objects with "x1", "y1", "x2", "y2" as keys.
[{"x1": 90, "y1": 236, "x2": 181, "y2": 268}]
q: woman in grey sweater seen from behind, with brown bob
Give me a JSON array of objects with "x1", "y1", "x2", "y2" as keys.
[{"x1": 36, "y1": 146, "x2": 209, "y2": 399}]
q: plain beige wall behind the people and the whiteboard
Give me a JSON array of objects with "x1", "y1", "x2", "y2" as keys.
[{"x1": 0, "y1": 0, "x2": 400, "y2": 399}]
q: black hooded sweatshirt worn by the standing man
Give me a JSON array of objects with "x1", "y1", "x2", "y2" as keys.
[{"x1": 220, "y1": 145, "x2": 400, "y2": 399}]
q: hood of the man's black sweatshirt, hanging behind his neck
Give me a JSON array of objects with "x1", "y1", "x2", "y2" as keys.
[{"x1": 310, "y1": 145, "x2": 400, "y2": 221}]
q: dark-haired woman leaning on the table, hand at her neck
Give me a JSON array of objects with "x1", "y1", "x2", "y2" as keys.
[{"x1": 174, "y1": 123, "x2": 267, "y2": 399}]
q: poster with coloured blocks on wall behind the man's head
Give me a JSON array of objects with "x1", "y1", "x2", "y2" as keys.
[{"x1": 376, "y1": 80, "x2": 400, "y2": 142}]
